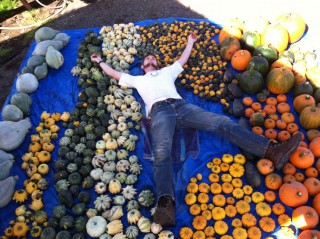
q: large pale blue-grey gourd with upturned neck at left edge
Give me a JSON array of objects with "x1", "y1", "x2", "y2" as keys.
[{"x1": 0, "y1": 118, "x2": 31, "y2": 151}]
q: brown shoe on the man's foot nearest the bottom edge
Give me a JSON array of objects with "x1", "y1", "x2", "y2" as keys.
[{"x1": 153, "y1": 196, "x2": 176, "y2": 226}]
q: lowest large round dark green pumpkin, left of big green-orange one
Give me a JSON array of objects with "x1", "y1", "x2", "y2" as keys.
[{"x1": 239, "y1": 66, "x2": 264, "y2": 94}]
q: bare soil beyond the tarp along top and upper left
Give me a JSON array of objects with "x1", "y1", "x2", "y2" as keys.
[{"x1": 0, "y1": 0, "x2": 204, "y2": 109}]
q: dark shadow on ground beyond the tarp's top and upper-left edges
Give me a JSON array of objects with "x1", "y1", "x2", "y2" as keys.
[{"x1": 0, "y1": 0, "x2": 203, "y2": 108}]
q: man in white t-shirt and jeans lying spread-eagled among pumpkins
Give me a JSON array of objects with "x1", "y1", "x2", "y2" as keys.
[{"x1": 91, "y1": 34, "x2": 301, "y2": 226}]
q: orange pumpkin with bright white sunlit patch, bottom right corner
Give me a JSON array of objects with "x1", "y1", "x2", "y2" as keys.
[{"x1": 292, "y1": 206, "x2": 319, "y2": 230}]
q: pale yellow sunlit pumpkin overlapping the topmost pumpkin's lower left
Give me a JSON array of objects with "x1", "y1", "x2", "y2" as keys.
[{"x1": 261, "y1": 23, "x2": 289, "y2": 52}]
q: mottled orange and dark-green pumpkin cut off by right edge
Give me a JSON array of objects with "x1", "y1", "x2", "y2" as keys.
[{"x1": 299, "y1": 105, "x2": 320, "y2": 129}]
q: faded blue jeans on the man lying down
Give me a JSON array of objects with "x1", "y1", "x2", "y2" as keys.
[{"x1": 150, "y1": 99, "x2": 270, "y2": 198}]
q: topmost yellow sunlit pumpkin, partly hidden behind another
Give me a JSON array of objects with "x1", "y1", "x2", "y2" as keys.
[{"x1": 276, "y1": 13, "x2": 306, "y2": 43}]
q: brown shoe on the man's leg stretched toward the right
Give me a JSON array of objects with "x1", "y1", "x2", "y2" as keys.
[{"x1": 265, "y1": 133, "x2": 302, "y2": 170}]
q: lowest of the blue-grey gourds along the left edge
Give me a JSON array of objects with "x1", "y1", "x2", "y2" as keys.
[{"x1": 0, "y1": 176, "x2": 18, "y2": 208}]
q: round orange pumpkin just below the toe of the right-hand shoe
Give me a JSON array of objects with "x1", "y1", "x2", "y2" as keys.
[{"x1": 290, "y1": 147, "x2": 314, "y2": 169}]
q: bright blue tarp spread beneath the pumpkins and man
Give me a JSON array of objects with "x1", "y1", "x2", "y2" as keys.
[{"x1": 0, "y1": 18, "x2": 318, "y2": 238}]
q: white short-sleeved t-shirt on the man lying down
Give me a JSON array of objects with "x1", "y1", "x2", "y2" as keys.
[{"x1": 119, "y1": 61, "x2": 183, "y2": 115}]
